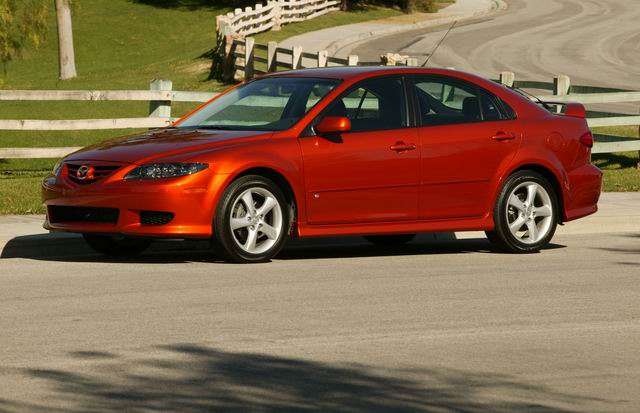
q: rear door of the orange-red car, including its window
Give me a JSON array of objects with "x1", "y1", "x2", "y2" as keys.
[{"x1": 412, "y1": 76, "x2": 522, "y2": 219}]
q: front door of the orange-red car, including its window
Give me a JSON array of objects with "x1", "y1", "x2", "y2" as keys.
[{"x1": 300, "y1": 76, "x2": 420, "y2": 225}]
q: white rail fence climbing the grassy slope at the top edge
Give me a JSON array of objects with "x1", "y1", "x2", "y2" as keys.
[{"x1": 216, "y1": 0, "x2": 340, "y2": 37}]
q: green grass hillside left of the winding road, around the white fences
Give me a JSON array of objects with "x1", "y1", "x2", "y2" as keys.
[{"x1": 0, "y1": 0, "x2": 410, "y2": 214}]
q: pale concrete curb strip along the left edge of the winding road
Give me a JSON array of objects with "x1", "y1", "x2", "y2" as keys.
[{"x1": 326, "y1": 0, "x2": 508, "y2": 56}]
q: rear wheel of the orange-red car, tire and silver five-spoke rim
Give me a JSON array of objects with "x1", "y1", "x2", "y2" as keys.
[{"x1": 486, "y1": 171, "x2": 559, "y2": 253}]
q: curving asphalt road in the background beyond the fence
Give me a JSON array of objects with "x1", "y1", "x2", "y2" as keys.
[{"x1": 348, "y1": 0, "x2": 640, "y2": 90}]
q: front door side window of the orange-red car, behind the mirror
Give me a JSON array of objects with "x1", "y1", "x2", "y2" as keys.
[{"x1": 322, "y1": 77, "x2": 407, "y2": 132}]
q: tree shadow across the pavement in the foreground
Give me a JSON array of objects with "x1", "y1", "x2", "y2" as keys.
[{"x1": 0, "y1": 344, "x2": 607, "y2": 413}]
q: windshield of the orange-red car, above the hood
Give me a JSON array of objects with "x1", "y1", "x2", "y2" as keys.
[{"x1": 178, "y1": 77, "x2": 339, "y2": 131}]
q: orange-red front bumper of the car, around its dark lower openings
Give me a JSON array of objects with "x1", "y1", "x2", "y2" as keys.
[{"x1": 42, "y1": 170, "x2": 226, "y2": 238}]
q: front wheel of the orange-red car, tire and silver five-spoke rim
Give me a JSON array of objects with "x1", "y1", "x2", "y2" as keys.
[{"x1": 212, "y1": 175, "x2": 291, "y2": 263}]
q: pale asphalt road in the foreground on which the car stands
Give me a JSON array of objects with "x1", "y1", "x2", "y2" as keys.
[{"x1": 0, "y1": 193, "x2": 640, "y2": 413}]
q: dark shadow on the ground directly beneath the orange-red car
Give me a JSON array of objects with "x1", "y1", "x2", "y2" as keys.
[{"x1": 0, "y1": 234, "x2": 564, "y2": 264}]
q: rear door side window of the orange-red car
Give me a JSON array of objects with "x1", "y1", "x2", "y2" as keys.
[{"x1": 414, "y1": 76, "x2": 513, "y2": 126}]
